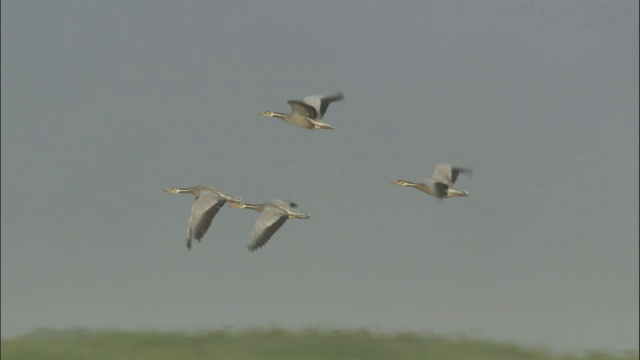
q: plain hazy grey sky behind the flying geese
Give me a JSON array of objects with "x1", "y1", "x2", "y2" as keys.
[{"x1": 1, "y1": 0, "x2": 639, "y2": 350}]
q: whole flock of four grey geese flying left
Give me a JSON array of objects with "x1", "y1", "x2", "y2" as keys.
[{"x1": 164, "y1": 92, "x2": 471, "y2": 251}]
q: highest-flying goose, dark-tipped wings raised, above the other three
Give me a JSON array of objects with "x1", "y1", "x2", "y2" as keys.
[{"x1": 259, "y1": 92, "x2": 344, "y2": 130}]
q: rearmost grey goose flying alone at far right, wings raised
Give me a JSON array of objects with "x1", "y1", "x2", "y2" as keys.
[{"x1": 392, "y1": 163, "x2": 472, "y2": 199}]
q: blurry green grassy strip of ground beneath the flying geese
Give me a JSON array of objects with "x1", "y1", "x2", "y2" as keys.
[{"x1": 2, "y1": 328, "x2": 638, "y2": 360}]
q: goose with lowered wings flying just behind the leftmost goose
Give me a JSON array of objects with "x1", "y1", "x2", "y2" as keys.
[{"x1": 229, "y1": 199, "x2": 311, "y2": 252}]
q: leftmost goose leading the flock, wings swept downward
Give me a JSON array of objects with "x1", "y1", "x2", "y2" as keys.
[{"x1": 163, "y1": 185, "x2": 242, "y2": 250}]
